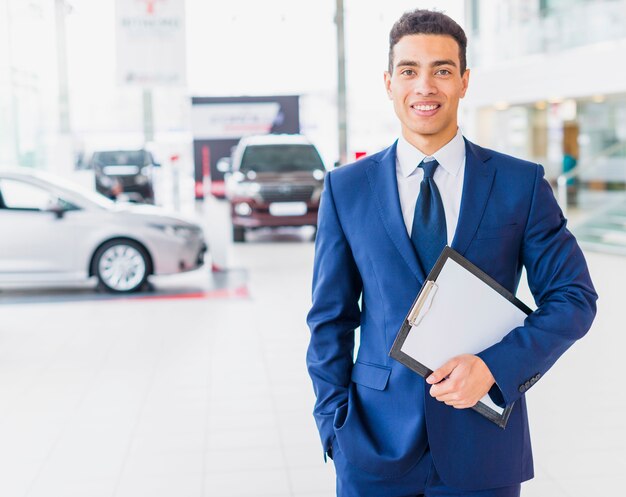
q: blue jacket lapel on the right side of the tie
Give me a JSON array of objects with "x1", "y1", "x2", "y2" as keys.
[{"x1": 452, "y1": 140, "x2": 495, "y2": 254}]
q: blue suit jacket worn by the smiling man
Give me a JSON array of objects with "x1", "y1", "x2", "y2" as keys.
[{"x1": 307, "y1": 141, "x2": 597, "y2": 490}]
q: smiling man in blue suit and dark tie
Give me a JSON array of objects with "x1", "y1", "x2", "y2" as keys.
[{"x1": 307, "y1": 10, "x2": 597, "y2": 497}]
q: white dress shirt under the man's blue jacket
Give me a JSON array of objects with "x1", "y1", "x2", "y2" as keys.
[{"x1": 396, "y1": 129, "x2": 465, "y2": 245}]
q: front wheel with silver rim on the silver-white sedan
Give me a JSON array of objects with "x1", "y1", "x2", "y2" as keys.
[{"x1": 94, "y1": 240, "x2": 149, "y2": 293}]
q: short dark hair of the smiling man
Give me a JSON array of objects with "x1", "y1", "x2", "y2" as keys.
[{"x1": 389, "y1": 9, "x2": 467, "y2": 74}]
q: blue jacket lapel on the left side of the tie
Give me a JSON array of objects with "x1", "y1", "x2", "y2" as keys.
[{"x1": 366, "y1": 142, "x2": 425, "y2": 282}]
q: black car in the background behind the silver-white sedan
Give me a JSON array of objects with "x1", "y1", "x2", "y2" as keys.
[{"x1": 90, "y1": 150, "x2": 159, "y2": 204}]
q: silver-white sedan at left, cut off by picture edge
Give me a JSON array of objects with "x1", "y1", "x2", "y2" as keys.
[{"x1": 0, "y1": 169, "x2": 207, "y2": 292}]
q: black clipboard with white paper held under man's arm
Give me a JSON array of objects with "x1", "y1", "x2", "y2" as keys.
[{"x1": 389, "y1": 246, "x2": 532, "y2": 428}]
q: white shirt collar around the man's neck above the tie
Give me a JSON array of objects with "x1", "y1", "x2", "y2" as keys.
[{"x1": 396, "y1": 128, "x2": 465, "y2": 177}]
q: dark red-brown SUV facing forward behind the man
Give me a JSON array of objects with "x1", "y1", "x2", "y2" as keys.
[{"x1": 226, "y1": 135, "x2": 326, "y2": 242}]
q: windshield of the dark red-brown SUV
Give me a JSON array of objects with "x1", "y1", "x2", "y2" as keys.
[{"x1": 239, "y1": 145, "x2": 324, "y2": 173}]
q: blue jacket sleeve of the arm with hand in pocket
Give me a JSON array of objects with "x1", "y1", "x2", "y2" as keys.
[{"x1": 307, "y1": 173, "x2": 362, "y2": 452}]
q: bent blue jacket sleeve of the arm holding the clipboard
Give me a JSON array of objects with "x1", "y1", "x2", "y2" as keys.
[{"x1": 478, "y1": 166, "x2": 597, "y2": 404}]
